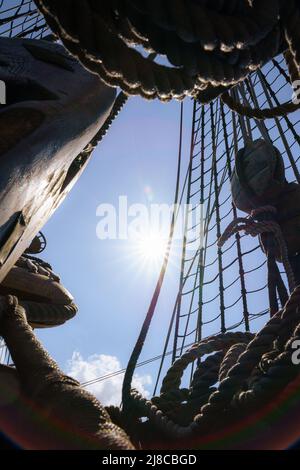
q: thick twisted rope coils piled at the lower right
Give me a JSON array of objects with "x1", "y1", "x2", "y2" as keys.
[{"x1": 119, "y1": 287, "x2": 300, "y2": 445}]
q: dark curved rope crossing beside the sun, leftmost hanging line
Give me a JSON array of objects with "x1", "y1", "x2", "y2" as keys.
[{"x1": 122, "y1": 103, "x2": 183, "y2": 410}]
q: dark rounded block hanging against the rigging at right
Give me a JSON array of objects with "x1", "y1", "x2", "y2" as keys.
[{"x1": 231, "y1": 139, "x2": 300, "y2": 261}]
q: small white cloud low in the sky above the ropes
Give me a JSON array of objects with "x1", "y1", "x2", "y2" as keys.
[{"x1": 67, "y1": 351, "x2": 152, "y2": 405}]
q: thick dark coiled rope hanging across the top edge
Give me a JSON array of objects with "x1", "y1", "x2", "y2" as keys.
[{"x1": 35, "y1": 0, "x2": 300, "y2": 102}]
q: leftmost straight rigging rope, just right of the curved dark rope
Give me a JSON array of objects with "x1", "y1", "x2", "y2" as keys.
[{"x1": 172, "y1": 100, "x2": 196, "y2": 362}]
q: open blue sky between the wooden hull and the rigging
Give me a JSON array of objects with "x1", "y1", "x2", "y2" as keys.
[{"x1": 38, "y1": 98, "x2": 192, "y2": 404}]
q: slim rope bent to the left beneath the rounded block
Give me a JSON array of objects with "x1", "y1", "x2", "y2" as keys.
[{"x1": 218, "y1": 206, "x2": 295, "y2": 292}]
